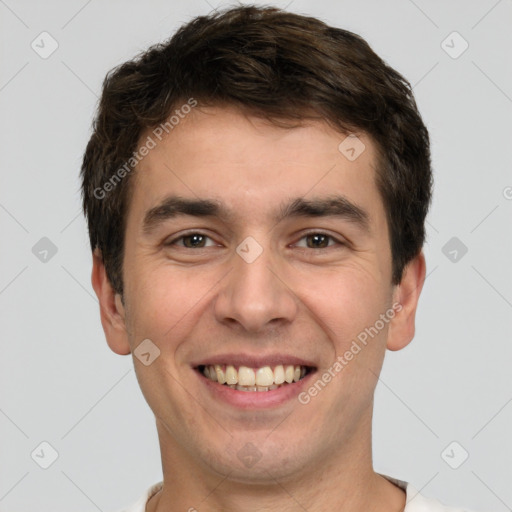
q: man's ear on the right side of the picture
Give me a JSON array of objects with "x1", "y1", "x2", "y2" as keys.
[{"x1": 387, "y1": 251, "x2": 426, "y2": 350}]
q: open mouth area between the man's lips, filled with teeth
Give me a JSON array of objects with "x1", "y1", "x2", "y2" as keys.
[{"x1": 197, "y1": 364, "x2": 314, "y2": 392}]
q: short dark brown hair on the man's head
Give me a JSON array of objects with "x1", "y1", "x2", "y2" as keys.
[{"x1": 81, "y1": 6, "x2": 432, "y2": 294}]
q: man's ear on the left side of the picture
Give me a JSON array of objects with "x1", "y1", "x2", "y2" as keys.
[{"x1": 91, "y1": 249, "x2": 131, "y2": 355}]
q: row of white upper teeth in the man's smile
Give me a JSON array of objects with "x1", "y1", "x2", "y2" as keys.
[{"x1": 203, "y1": 364, "x2": 306, "y2": 386}]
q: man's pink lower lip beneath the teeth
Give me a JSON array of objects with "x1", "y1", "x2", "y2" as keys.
[{"x1": 195, "y1": 370, "x2": 315, "y2": 409}]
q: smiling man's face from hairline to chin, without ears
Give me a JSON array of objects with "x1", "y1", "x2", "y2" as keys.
[{"x1": 107, "y1": 108, "x2": 408, "y2": 481}]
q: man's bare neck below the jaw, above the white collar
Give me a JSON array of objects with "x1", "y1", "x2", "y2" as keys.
[{"x1": 146, "y1": 417, "x2": 405, "y2": 512}]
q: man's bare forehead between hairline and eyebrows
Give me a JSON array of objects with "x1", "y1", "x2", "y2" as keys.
[{"x1": 133, "y1": 107, "x2": 382, "y2": 226}]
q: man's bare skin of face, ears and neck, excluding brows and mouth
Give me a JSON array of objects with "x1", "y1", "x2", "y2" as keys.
[{"x1": 92, "y1": 107, "x2": 425, "y2": 512}]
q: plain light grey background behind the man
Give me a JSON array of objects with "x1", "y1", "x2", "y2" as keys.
[{"x1": 0, "y1": 0, "x2": 512, "y2": 512}]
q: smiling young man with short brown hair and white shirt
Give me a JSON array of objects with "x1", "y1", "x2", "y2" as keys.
[{"x1": 82, "y1": 6, "x2": 476, "y2": 512}]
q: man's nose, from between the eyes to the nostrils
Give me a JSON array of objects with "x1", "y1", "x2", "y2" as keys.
[{"x1": 215, "y1": 238, "x2": 298, "y2": 333}]
